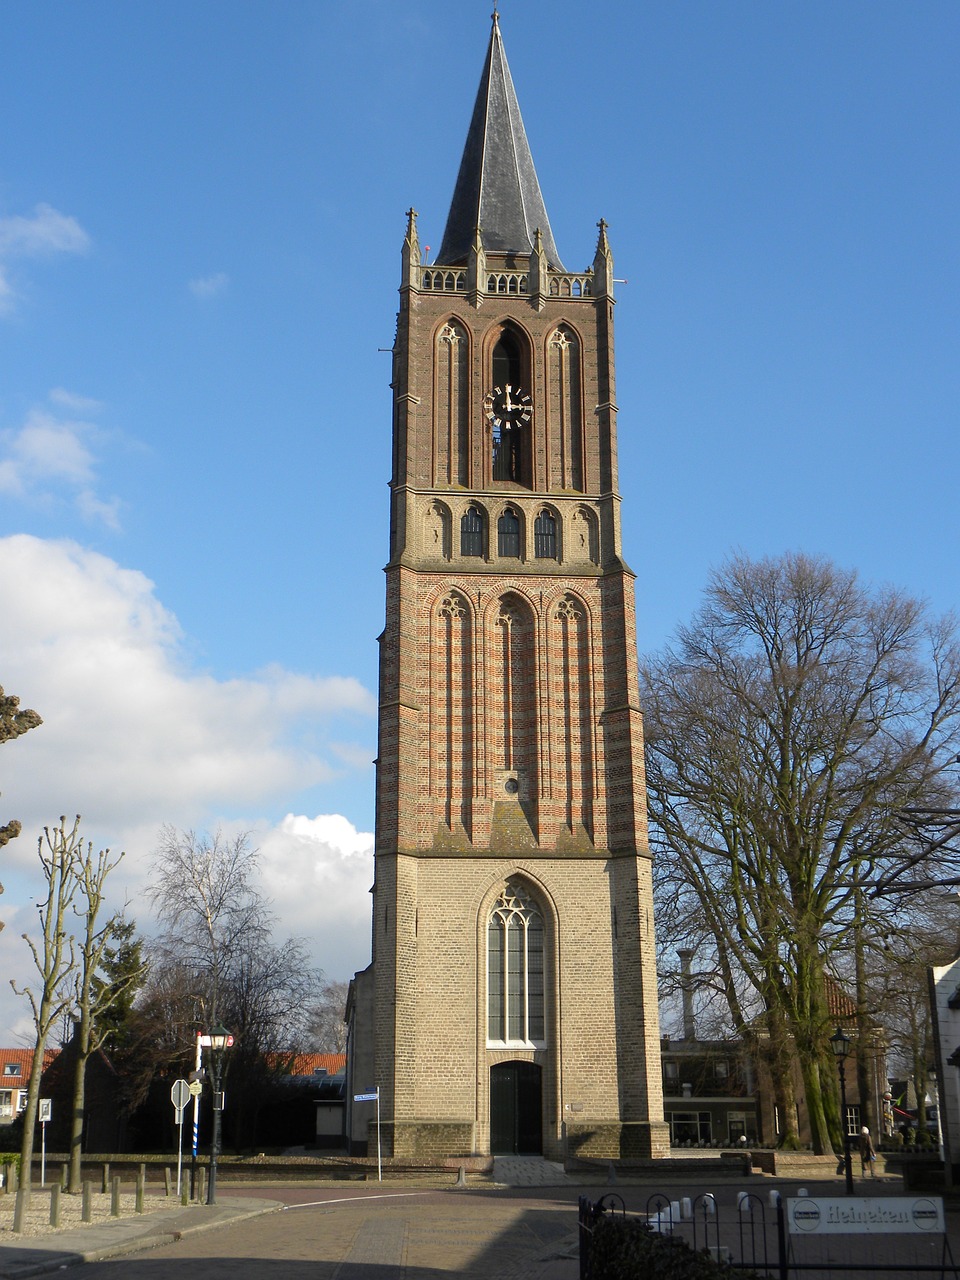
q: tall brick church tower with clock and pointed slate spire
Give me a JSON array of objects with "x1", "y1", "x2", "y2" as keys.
[{"x1": 351, "y1": 14, "x2": 667, "y2": 1158}]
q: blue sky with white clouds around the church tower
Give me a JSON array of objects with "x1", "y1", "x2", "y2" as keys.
[{"x1": 0, "y1": 0, "x2": 960, "y2": 1039}]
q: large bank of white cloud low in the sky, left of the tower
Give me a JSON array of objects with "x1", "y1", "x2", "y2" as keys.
[{"x1": 0, "y1": 534, "x2": 376, "y2": 1043}]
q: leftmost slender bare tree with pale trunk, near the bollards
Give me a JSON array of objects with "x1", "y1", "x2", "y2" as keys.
[{"x1": 10, "y1": 818, "x2": 82, "y2": 1178}]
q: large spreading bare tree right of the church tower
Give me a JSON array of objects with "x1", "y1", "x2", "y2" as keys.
[{"x1": 641, "y1": 554, "x2": 960, "y2": 1152}]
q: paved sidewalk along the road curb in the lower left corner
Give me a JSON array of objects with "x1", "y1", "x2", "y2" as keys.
[{"x1": 0, "y1": 1196, "x2": 283, "y2": 1280}]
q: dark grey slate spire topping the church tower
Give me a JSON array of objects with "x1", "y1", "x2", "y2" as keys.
[{"x1": 436, "y1": 10, "x2": 563, "y2": 271}]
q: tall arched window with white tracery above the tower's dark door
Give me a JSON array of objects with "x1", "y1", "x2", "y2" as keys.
[{"x1": 486, "y1": 881, "x2": 545, "y2": 1044}]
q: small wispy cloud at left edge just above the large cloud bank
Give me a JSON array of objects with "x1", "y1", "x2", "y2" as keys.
[{"x1": 0, "y1": 401, "x2": 120, "y2": 529}]
